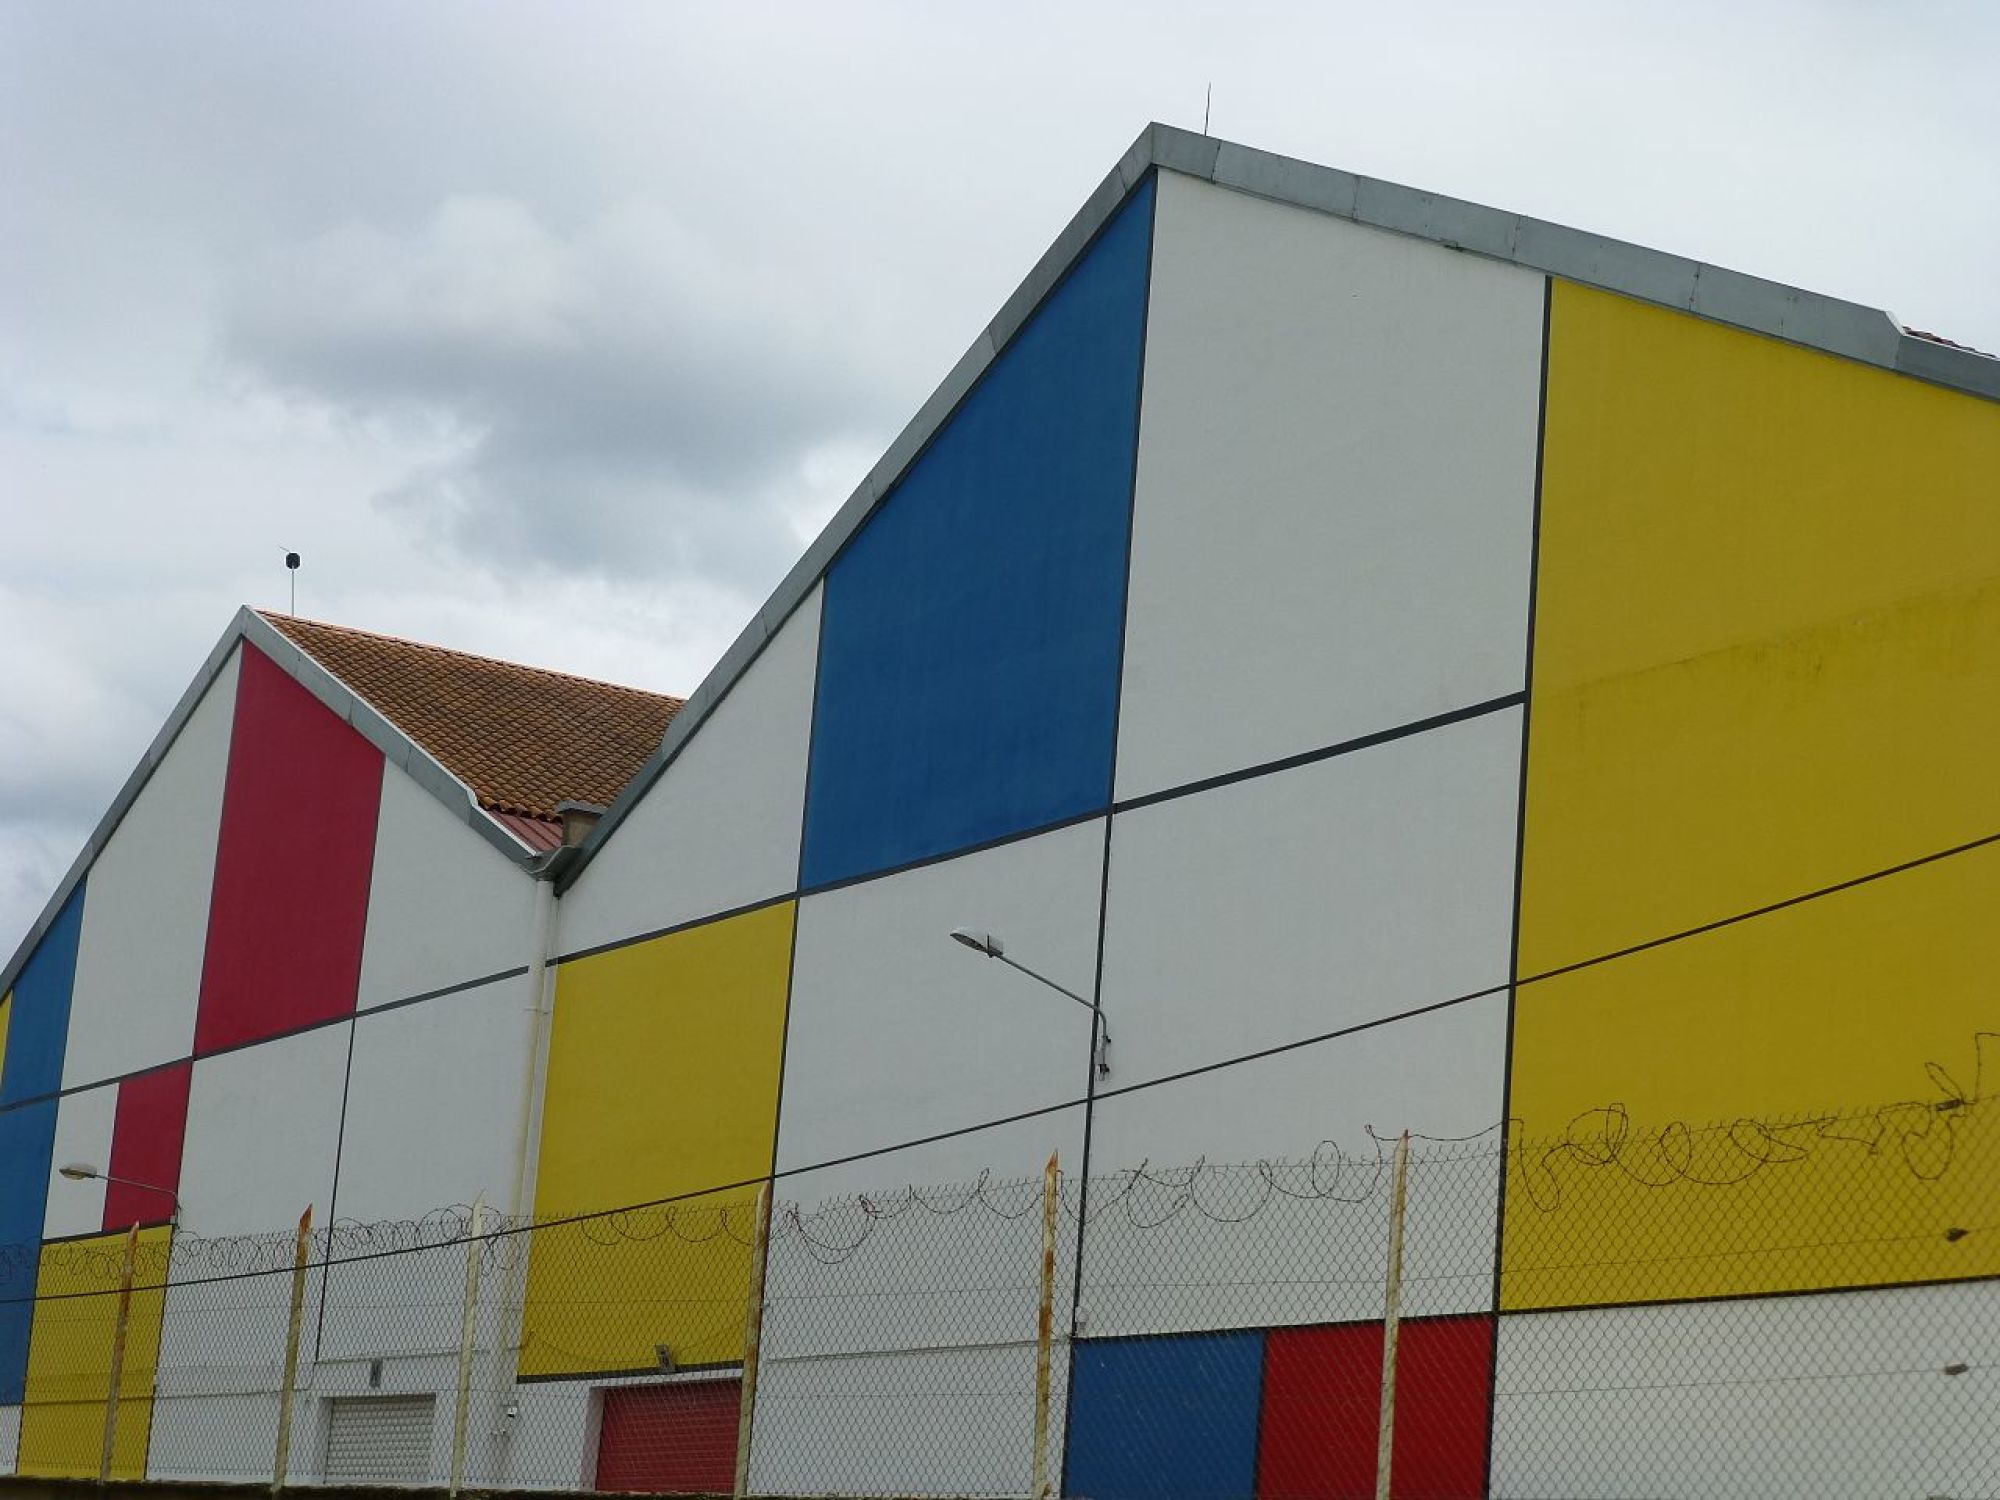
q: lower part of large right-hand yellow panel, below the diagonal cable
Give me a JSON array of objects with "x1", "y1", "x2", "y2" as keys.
[{"x1": 1500, "y1": 848, "x2": 2000, "y2": 1308}]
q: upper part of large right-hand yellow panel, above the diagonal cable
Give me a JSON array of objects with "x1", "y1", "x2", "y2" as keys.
[{"x1": 1520, "y1": 284, "x2": 2000, "y2": 974}]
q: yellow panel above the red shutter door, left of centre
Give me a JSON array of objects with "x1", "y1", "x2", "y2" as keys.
[{"x1": 520, "y1": 902, "x2": 794, "y2": 1376}]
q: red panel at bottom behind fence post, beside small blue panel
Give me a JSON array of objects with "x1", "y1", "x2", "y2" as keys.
[{"x1": 1256, "y1": 1316, "x2": 1494, "y2": 1500}]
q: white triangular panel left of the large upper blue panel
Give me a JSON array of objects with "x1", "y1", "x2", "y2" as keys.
[{"x1": 562, "y1": 588, "x2": 820, "y2": 952}]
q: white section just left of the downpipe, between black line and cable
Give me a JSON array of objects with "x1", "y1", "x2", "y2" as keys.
[{"x1": 336, "y1": 976, "x2": 532, "y2": 1224}]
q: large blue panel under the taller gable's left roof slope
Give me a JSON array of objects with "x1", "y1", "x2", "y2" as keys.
[{"x1": 800, "y1": 178, "x2": 1152, "y2": 886}]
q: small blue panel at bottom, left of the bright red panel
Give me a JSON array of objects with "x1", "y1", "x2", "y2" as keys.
[{"x1": 1062, "y1": 1330, "x2": 1264, "y2": 1500}]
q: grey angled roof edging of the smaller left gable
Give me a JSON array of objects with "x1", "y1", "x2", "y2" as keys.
[{"x1": 0, "y1": 604, "x2": 548, "y2": 994}]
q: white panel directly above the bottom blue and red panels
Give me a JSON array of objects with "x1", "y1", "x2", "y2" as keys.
[{"x1": 1082, "y1": 710, "x2": 1520, "y2": 1334}]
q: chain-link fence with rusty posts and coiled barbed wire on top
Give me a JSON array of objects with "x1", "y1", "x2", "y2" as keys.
[{"x1": 0, "y1": 1098, "x2": 2000, "y2": 1500}]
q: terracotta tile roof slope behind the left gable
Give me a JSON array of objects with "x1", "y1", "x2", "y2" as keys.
[{"x1": 260, "y1": 610, "x2": 682, "y2": 846}]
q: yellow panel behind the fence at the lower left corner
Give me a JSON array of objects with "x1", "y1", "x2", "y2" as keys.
[{"x1": 20, "y1": 1226, "x2": 172, "y2": 1480}]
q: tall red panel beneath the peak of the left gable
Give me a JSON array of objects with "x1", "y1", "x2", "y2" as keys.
[{"x1": 194, "y1": 646, "x2": 382, "y2": 1054}]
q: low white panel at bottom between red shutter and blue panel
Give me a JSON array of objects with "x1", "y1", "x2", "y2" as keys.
[{"x1": 750, "y1": 1344, "x2": 1070, "y2": 1496}]
